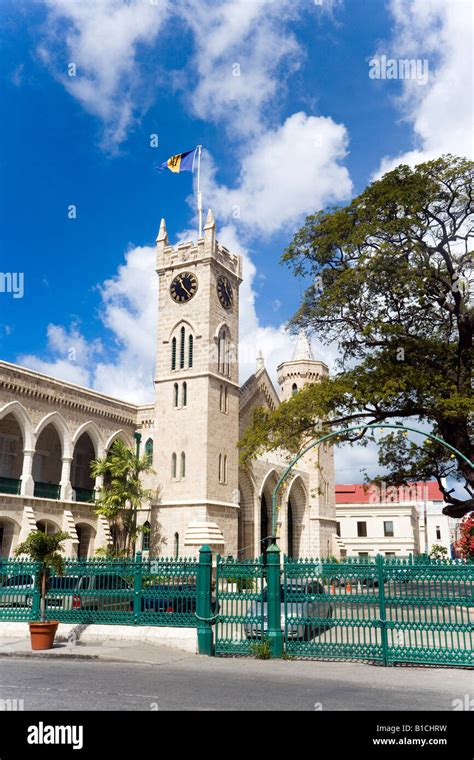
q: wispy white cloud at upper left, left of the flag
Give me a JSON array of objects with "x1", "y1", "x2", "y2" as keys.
[{"x1": 38, "y1": 0, "x2": 169, "y2": 150}]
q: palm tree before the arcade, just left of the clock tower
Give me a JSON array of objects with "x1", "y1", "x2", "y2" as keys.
[{"x1": 91, "y1": 439, "x2": 154, "y2": 556}]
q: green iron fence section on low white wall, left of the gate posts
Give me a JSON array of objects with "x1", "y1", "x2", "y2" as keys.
[{"x1": 0, "y1": 555, "x2": 198, "y2": 626}]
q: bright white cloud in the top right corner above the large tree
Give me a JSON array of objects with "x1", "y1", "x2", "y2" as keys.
[{"x1": 376, "y1": 0, "x2": 474, "y2": 176}]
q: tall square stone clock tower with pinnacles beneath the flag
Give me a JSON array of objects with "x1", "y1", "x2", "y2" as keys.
[{"x1": 154, "y1": 211, "x2": 242, "y2": 555}]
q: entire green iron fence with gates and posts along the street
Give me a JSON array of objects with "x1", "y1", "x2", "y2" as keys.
[{"x1": 0, "y1": 546, "x2": 474, "y2": 667}]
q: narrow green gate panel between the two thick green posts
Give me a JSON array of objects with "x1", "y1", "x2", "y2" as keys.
[{"x1": 215, "y1": 555, "x2": 267, "y2": 655}]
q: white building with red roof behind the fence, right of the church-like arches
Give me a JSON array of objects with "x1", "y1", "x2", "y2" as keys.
[{"x1": 336, "y1": 482, "x2": 451, "y2": 557}]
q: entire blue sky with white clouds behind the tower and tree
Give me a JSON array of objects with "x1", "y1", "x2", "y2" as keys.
[{"x1": 0, "y1": 0, "x2": 472, "y2": 480}]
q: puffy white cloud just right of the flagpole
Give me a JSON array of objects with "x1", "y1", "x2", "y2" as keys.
[{"x1": 203, "y1": 112, "x2": 352, "y2": 234}]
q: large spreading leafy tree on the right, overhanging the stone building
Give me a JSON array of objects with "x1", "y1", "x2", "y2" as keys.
[{"x1": 241, "y1": 155, "x2": 474, "y2": 517}]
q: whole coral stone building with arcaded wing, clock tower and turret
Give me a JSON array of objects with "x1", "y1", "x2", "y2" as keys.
[{"x1": 0, "y1": 212, "x2": 338, "y2": 557}]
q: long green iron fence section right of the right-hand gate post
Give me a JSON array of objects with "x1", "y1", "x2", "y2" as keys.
[{"x1": 283, "y1": 556, "x2": 474, "y2": 666}]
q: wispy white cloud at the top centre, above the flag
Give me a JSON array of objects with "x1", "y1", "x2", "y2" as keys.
[{"x1": 180, "y1": 0, "x2": 305, "y2": 137}]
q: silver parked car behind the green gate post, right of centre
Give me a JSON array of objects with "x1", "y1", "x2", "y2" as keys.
[{"x1": 244, "y1": 578, "x2": 332, "y2": 640}]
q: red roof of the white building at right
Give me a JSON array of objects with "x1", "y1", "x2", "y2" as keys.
[{"x1": 336, "y1": 480, "x2": 443, "y2": 504}]
